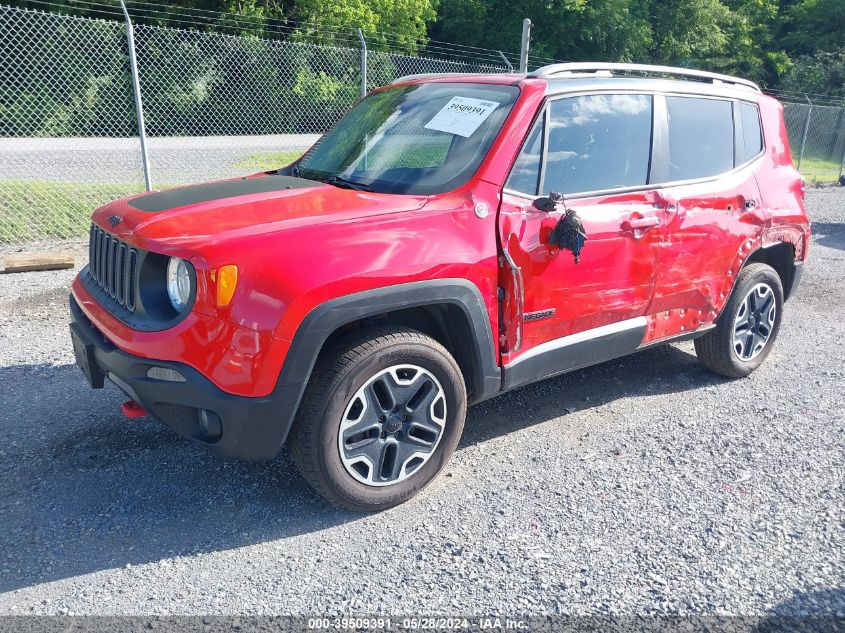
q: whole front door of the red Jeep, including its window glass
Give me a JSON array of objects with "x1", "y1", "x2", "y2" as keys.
[{"x1": 499, "y1": 93, "x2": 666, "y2": 387}]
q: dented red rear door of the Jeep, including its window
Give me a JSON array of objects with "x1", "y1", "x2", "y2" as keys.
[{"x1": 651, "y1": 95, "x2": 767, "y2": 328}]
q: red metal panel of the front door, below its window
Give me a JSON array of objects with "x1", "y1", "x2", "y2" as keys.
[{"x1": 499, "y1": 191, "x2": 665, "y2": 361}]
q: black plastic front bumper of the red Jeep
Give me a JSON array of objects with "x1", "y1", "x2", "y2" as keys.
[{"x1": 70, "y1": 296, "x2": 291, "y2": 461}]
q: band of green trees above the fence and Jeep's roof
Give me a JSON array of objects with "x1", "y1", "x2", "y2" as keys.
[{"x1": 9, "y1": 0, "x2": 845, "y2": 94}]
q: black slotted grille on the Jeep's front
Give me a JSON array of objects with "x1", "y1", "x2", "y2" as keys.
[{"x1": 88, "y1": 224, "x2": 138, "y2": 312}]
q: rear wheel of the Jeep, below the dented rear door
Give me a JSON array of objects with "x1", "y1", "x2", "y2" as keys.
[{"x1": 695, "y1": 264, "x2": 783, "y2": 378}]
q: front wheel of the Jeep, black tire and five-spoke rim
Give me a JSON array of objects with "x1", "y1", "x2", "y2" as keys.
[{"x1": 288, "y1": 326, "x2": 467, "y2": 512}]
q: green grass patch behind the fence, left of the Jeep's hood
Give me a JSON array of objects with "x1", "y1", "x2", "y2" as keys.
[{"x1": 0, "y1": 180, "x2": 143, "y2": 244}]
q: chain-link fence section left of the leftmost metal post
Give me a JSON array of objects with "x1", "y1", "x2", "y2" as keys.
[{"x1": 0, "y1": 6, "x2": 143, "y2": 244}]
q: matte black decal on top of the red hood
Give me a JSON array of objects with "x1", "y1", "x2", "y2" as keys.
[{"x1": 129, "y1": 175, "x2": 320, "y2": 213}]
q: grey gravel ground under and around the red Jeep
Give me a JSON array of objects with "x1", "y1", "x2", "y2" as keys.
[{"x1": 0, "y1": 189, "x2": 845, "y2": 617}]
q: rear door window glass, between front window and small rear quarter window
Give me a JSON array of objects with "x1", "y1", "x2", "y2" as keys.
[{"x1": 666, "y1": 97, "x2": 734, "y2": 180}]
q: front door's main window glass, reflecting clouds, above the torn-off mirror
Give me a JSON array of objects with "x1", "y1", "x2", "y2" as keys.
[{"x1": 543, "y1": 94, "x2": 653, "y2": 193}]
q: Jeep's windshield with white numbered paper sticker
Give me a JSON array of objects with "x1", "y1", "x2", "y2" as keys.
[{"x1": 286, "y1": 83, "x2": 519, "y2": 194}]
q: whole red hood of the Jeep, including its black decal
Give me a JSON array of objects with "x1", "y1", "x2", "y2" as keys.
[{"x1": 92, "y1": 174, "x2": 427, "y2": 250}]
